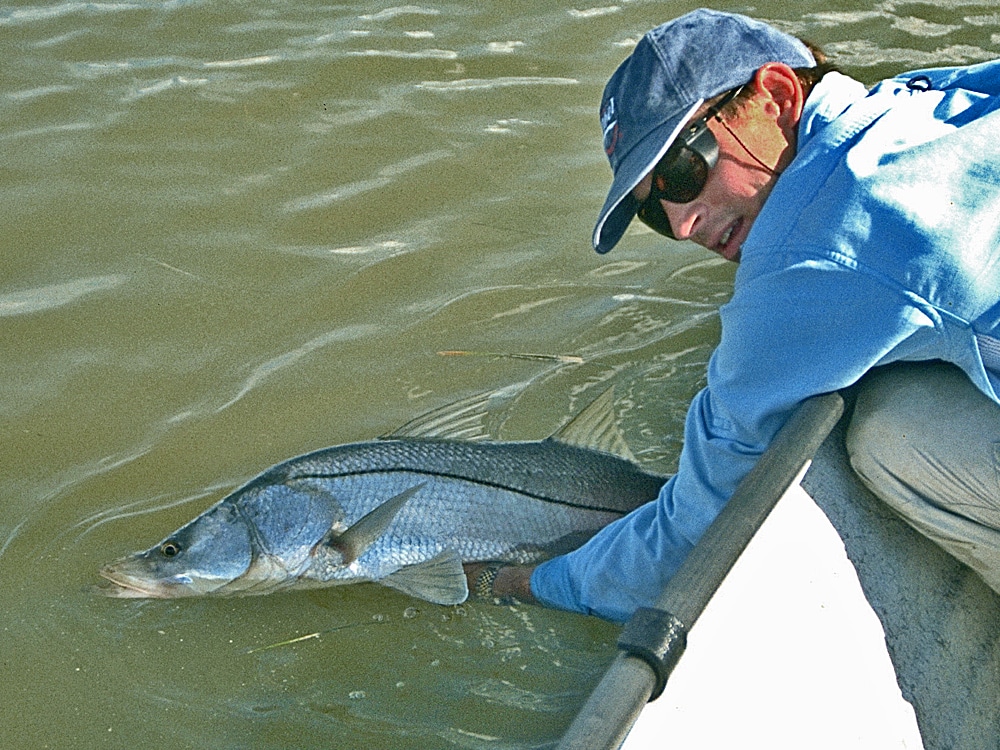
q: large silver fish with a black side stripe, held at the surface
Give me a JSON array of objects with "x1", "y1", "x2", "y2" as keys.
[{"x1": 99, "y1": 389, "x2": 667, "y2": 605}]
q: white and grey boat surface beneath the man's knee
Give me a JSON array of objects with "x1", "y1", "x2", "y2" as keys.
[{"x1": 623, "y1": 426, "x2": 1000, "y2": 750}]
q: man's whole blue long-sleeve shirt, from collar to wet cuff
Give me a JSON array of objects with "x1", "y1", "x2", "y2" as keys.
[{"x1": 531, "y1": 61, "x2": 1000, "y2": 621}]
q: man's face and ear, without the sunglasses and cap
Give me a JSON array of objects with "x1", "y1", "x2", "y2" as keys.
[{"x1": 633, "y1": 83, "x2": 794, "y2": 262}]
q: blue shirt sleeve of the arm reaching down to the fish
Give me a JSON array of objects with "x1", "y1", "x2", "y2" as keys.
[{"x1": 531, "y1": 259, "x2": 934, "y2": 622}]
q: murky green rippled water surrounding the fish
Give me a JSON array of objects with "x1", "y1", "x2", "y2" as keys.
[{"x1": 0, "y1": 0, "x2": 1000, "y2": 749}]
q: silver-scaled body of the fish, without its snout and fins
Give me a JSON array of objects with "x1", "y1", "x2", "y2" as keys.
[{"x1": 231, "y1": 438, "x2": 665, "y2": 585}]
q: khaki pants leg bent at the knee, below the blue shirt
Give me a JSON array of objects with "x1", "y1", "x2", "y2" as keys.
[{"x1": 847, "y1": 362, "x2": 1000, "y2": 593}]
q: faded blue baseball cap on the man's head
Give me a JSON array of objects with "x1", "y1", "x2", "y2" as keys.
[{"x1": 594, "y1": 8, "x2": 816, "y2": 253}]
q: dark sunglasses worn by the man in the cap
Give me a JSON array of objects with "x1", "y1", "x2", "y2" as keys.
[{"x1": 636, "y1": 86, "x2": 743, "y2": 240}]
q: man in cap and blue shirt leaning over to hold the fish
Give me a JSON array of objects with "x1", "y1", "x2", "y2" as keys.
[{"x1": 470, "y1": 10, "x2": 1000, "y2": 621}]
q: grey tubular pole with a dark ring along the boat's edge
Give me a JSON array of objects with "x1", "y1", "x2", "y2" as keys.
[{"x1": 557, "y1": 393, "x2": 844, "y2": 750}]
